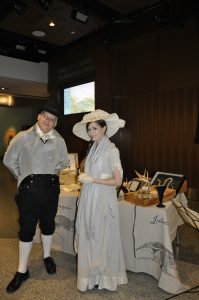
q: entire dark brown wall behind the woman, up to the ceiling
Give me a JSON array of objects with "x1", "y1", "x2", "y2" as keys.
[{"x1": 49, "y1": 18, "x2": 199, "y2": 188}]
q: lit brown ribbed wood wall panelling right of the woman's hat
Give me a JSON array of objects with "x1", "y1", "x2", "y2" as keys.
[{"x1": 114, "y1": 90, "x2": 199, "y2": 187}]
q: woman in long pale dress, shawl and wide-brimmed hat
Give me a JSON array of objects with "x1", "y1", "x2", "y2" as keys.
[{"x1": 73, "y1": 110, "x2": 128, "y2": 291}]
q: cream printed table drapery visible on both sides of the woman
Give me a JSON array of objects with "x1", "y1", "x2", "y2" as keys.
[{"x1": 34, "y1": 190, "x2": 189, "y2": 294}]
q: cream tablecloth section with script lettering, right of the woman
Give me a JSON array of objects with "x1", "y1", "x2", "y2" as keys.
[{"x1": 119, "y1": 194, "x2": 189, "y2": 294}]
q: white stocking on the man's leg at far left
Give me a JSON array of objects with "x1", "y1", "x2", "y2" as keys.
[{"x1": 18, "y1": 241, "x2": 32, "y2": 273}]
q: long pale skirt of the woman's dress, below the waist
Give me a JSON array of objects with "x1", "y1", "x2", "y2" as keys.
[{"x1": 75, "y1": 184, "x2": 128, "y2": 291}]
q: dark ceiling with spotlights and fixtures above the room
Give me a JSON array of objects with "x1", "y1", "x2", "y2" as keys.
[{"x1": 0, "y1": 0, "x2": 199, "y2": 62}]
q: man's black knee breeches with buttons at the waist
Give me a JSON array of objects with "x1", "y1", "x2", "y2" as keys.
[{"x1": 16, "y1": 175, "x2": 60, "y2": 242}]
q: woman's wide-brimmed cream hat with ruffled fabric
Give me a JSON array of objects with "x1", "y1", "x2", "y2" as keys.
[{"x1": 73, "y1": 109, "x2": 125, "y2": 141}]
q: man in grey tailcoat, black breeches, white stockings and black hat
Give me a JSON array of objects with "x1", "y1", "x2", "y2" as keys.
[{"x1": 3, "y1": 104, "x2": 68, "y2": 293}]
